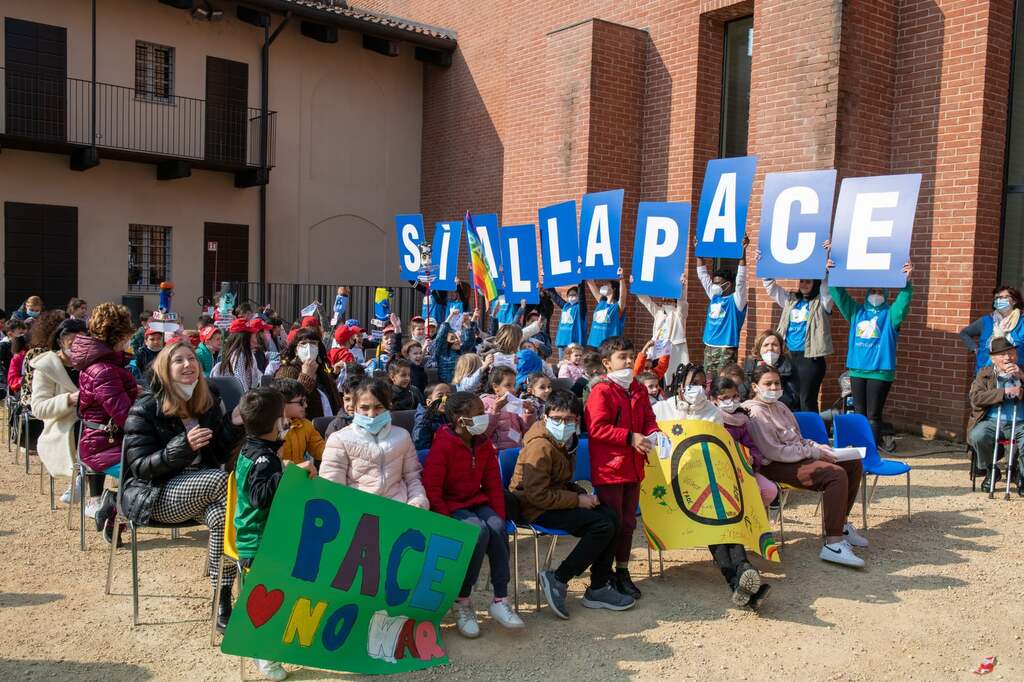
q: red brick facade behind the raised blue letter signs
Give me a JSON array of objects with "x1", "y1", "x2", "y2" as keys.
[{"x1": 368, "y1": 0, "x2": 1013, "y2": 435}]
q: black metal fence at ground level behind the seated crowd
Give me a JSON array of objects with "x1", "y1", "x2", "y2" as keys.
[{"x1": 229, "y1": 282, "x2": 423, "y2": 327}]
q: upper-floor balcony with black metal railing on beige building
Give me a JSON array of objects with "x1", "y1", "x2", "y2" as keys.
[{"x1": 0, "y1": 68, "x2": 276, "y2": 186}]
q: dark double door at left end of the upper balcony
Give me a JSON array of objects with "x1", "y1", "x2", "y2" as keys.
[{"x1": 4, "y1": 16, "x2": 68, "y2": 142}]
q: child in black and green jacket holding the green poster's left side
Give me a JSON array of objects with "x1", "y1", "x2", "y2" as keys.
[{"x1": 233, "y1": 382, "x2": 316, "y2": 680}]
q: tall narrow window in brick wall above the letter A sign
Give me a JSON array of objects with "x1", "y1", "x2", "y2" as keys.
[{"x1": 719, "y1": 16, "x2": 754, "y2": 157}]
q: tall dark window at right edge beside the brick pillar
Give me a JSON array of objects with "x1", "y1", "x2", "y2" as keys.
[{"x1": 1000, "y1": 2, "x2": 1024, "y2": 289}]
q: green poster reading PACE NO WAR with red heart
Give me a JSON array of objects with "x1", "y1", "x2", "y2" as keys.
[{"x1": 220, "y1": 467, "x2": 478, "y2": 674}]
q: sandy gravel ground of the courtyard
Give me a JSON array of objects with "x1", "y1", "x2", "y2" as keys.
[{"x1": 0, "y1": 436, "x2": 1024, "y2": 682}]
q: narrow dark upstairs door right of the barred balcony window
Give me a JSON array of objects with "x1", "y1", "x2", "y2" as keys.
[{"x1": 206, "y1": 56, "x2": 249, "y2": 166}]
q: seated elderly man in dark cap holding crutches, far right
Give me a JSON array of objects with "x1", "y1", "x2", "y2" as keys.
[{"x1": 968, "y1": 337, "x2": 1024, "y2": 495}]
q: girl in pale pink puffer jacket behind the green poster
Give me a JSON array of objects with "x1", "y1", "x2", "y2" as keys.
[{"x1": 319, "y1": 379, "x2": 430, "y2": 509}]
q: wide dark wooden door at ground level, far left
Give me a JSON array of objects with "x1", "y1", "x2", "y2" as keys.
[{"x1": 4, "y1": 202, "x2": 78, "y2": 310}]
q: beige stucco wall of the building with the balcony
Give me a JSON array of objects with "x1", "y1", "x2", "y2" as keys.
[{"x1": 0, "y1": 0, "x2": 423, "y2": 318}]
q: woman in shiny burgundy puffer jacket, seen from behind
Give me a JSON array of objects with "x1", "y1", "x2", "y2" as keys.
[{"x1": 71, "y1": 303, "x2": 138, "y2": 537}]
